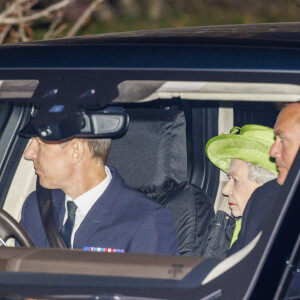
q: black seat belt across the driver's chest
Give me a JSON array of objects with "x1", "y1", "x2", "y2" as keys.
[{"x1": 36, "y1": 177, "x2": 67, "y2": 248}]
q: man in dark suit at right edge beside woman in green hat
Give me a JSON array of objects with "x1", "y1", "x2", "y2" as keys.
[{"x1": 228, "y1": 102, "x2": 300, "y2": 255}]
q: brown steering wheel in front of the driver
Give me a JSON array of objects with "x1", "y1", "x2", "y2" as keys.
[{"x1": 0, "y1": 208, "x2": 35, "y2": 247}]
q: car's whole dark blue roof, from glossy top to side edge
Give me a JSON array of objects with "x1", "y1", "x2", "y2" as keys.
[{"x1": 0, "y1": 23, "x2": 300, "y2": 70}]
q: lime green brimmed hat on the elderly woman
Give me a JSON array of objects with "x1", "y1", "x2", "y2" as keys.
[{"x1": 205, "y1": 125, "x2": 278, "y2": 174}]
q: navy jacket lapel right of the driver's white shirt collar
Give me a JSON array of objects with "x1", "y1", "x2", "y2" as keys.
[{"x1": 73, "y1": 167, "x2": 123, "y2": 249}]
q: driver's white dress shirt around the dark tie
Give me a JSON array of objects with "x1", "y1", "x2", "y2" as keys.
[{"x1": 63, "y1": 166, "x2": 112, "y2": 248}]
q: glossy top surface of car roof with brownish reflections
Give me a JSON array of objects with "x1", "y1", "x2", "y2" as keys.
[{"x1": 3, "y1": 22, "x2": 300, "y2": 47}]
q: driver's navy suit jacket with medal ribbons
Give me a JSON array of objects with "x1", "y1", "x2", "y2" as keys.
[{"x1": 20, "y1": 168, "x2": 178, "y2": 254}]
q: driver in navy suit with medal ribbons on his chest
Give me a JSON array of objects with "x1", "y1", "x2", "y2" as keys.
[{"x1": 20, "y1": 137, "x2": 178, "y2": 254}]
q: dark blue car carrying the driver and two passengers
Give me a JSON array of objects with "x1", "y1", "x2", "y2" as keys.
[{"x1": 0, "y1": 23, "x2": 300, "y2": 300}]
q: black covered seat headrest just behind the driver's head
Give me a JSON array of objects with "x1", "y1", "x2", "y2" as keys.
[{"x1": 108, "y1": 108, "x2": 187, "y2": 198}]
